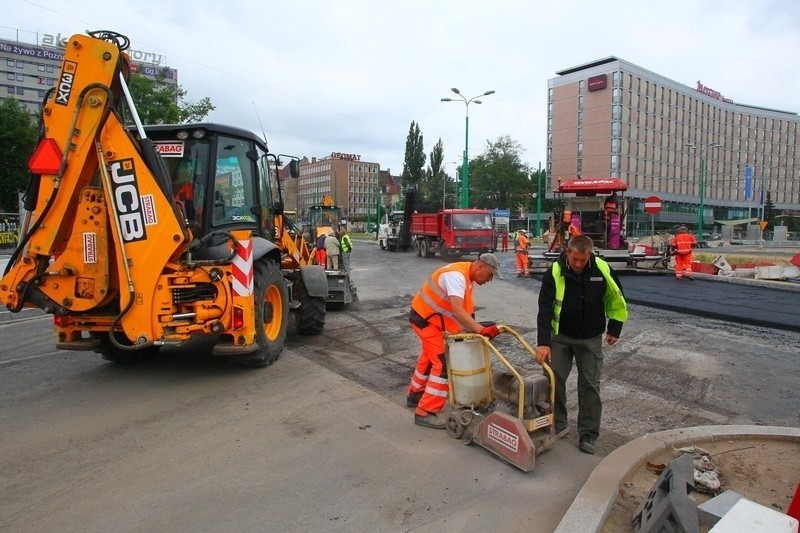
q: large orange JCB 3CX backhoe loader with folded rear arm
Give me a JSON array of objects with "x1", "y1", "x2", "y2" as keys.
[{"x1": 0, "y1": 31, "x2": 328, "y2": 367}]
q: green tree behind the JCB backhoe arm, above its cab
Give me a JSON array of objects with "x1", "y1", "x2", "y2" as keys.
[{"x1": 128, "y1": 68, "x2": 216, "y2": 124}]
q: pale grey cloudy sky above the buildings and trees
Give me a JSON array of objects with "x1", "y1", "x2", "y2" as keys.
[{"x1": 0, "y1": 0, "x2": 800, "y2": 174}]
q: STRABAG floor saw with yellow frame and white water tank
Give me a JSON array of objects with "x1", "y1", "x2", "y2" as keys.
[{"x1": 445, "y1": 325, "x2": 568, "y2": 472}]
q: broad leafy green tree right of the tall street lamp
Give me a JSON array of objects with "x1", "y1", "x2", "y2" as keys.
[{"x1": 469, "y1": 136, "x2": 532, "y2": 212}]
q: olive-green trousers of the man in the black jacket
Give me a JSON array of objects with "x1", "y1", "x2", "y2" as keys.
[{"x1": 550, "y1": 335, "x2": 603, "y2": 439}]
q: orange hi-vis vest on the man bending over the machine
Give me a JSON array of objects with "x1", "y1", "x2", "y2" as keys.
[{"x1": 411, "y1": 261, "x2": 475, "y2": 333}]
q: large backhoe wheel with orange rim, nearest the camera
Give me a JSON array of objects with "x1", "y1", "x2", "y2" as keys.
[{"x1": 233, "y1": 261, "x2": 289, "y2": 367}]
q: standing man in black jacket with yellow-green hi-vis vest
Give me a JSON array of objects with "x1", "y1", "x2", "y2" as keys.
[{"x1": 536, "y1": 235, "x2": 628, "y2": 454}]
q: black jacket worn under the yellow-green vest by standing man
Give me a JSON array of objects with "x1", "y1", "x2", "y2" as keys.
[{"x1": 536, "y1": 252, "x2": 622, "y2": 346}]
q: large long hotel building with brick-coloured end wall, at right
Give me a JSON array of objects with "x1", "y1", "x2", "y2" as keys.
[{"x1": 547, "y1": 57, "x2": 800, "y2": 236}]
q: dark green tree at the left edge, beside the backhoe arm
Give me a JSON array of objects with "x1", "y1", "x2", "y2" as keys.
[{"x1": 0, "y1": 98, "x2": 38, "y2": 213}]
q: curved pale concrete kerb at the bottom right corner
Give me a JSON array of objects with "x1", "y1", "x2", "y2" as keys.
[{"x1": 556, "y1": 425, "x2": 800, "y2": 533}]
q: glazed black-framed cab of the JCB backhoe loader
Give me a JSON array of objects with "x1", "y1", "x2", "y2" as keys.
[{"x1": 145, "y1": 123, "x2": 281, "y2": 240}]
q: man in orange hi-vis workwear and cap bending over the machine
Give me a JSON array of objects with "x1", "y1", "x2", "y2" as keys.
[{"x1": 406, "y1": 253, "x2": 503, "y2": 429}]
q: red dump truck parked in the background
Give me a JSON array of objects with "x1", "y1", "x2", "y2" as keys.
[{"x1": 411, "y1": 209, "x2": 495, "y2": 257}]
